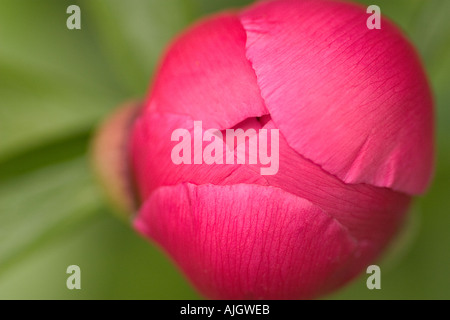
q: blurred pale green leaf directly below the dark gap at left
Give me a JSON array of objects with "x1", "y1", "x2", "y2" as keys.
[{"x1": 0, "y1": 158, "x2": 102, "y2": 275}]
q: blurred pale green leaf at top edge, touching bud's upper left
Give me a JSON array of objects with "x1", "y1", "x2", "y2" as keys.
[{"x1": 81, "y1": 0, "x2": 190, "y2": 95}]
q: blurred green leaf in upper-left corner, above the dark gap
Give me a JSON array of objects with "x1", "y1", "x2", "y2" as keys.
[{"x1": 0, "y1": 0, "x2": 126, "y2": 159}]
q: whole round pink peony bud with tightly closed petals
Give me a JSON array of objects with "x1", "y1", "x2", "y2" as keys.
[{"x1": 120, "y1": 0, "x2": 433, "y2": 299}]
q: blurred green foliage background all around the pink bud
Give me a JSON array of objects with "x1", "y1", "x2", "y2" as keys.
[{"x1": 0, "y1": 0, "x2": 450, "y2": 299}]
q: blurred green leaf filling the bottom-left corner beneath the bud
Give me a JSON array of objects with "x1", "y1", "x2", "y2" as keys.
[{"x1": 0, "y1": 211, "x2": 199, "y2": 299}]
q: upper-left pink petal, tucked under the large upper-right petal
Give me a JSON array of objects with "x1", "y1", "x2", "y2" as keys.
[{"x1": 147, "y1": 13, "x2": 267, "y2": 129}]
